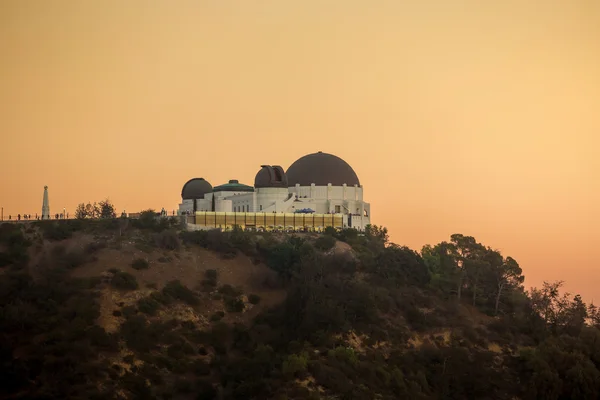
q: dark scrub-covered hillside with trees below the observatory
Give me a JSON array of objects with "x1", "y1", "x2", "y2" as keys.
[{"x1": 0, "y1": 215, "x2": 600, "y2": 400}]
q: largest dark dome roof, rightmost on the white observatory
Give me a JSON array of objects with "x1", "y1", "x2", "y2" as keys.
[{"x1": 286, "y1": 151, "x2": 360, "y2": 186}]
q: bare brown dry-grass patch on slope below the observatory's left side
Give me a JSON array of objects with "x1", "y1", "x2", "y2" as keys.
[{"x1": 32, "y1": 230, "x2": 286, "y2": 332}]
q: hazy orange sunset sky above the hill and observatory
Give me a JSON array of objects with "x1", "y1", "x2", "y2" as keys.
[{"x1": 0, "y1": 0, "x2": 600, "y2": 303}]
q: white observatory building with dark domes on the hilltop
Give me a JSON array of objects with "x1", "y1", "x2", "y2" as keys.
[{"x1": 179, "y1": 151, "x2": 371, "y2": 230}]
